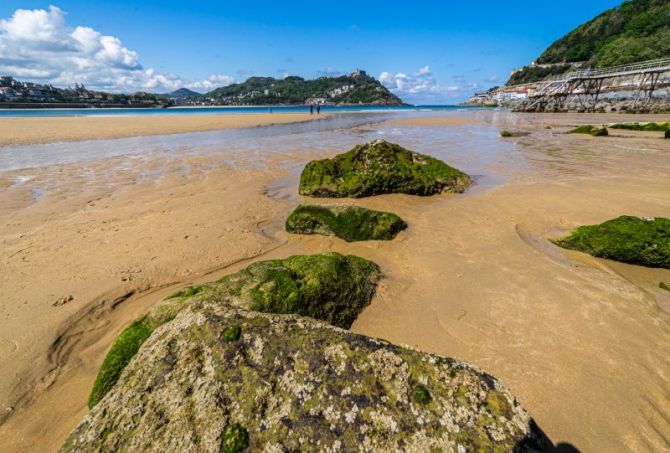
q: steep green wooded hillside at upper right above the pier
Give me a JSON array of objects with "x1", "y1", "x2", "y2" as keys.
[{"x1": 508, "y1": 0, "x2": 670, "y2": 85}]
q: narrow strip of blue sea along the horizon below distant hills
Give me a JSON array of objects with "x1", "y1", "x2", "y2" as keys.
[{"x1": 0, "y1": 105, "x2": 472, "y2": 117}]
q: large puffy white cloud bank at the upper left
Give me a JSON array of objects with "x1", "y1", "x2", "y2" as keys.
[{"x1": 0, "y1": 6, "x2": 235, "y2": 92}]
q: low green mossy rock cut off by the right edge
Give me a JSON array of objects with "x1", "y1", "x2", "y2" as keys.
[{"x1": 555, "y1": 216, "x2": 670, "y2": 269}]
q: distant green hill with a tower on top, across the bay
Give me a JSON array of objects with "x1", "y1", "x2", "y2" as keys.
[{"x1": 203, "y1": 71, "x2": 403, "y2": 105}]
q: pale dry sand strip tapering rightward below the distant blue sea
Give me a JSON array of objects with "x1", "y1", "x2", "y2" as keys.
[{"x1": 0, "y1": 113, "x2": 318, "y2": 146}]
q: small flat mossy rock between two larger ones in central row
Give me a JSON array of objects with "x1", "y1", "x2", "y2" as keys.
[{"x1": 286, "y1": 205, "x2": 407, "y2": 242}]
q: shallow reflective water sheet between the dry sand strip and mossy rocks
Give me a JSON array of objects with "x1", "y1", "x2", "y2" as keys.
[{"x1": 0, "y1": 111, "x2": 527, "y2": 210}]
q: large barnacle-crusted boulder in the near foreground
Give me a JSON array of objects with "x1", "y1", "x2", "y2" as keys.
[{"x1": 61, "y1": 300, "x2": 549, "y2": 452}]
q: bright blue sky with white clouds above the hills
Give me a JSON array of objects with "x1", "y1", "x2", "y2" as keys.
[{"x1": 0, "y1": 0, "x2": 620, "y2": 103}]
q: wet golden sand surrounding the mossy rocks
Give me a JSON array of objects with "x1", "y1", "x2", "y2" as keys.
[{"x1": 0, "y1": 112, "x2": 670, "y2": 452}]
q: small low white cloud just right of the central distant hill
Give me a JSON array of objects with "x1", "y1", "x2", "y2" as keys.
[{"x1": 378, "y1": 66, "x2": 477, "y2": 103}]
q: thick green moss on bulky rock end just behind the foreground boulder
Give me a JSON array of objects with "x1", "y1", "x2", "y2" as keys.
[{"x1": 224, "y1": 253, "x2": 381, "y2": 329}]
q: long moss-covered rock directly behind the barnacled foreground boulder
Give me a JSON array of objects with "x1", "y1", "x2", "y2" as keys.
[{"x1": 88, "y1": 253, "x2": 381, "y2": 408}]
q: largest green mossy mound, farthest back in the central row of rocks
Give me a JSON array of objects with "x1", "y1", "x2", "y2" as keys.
[{"x1": 299, "y1": 140, "x2": 473, "y2": 198}]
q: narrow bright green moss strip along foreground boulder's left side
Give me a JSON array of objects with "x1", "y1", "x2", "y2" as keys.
[{"x1": 88, "y1": 317, "x2": 153, "y2": 408}]
